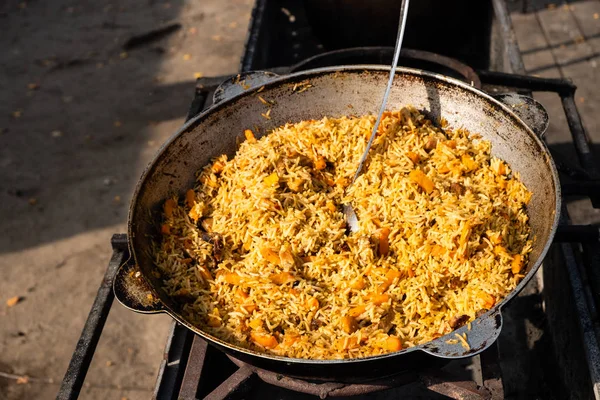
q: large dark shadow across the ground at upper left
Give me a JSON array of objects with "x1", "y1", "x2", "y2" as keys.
[{"x1": 0, "y1": 1, "x2": 204, "y2": 253}]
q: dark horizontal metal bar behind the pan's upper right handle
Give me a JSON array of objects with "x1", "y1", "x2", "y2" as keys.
[{"x1": 476, "y1": 70, "x2": 577, "y2": 95}]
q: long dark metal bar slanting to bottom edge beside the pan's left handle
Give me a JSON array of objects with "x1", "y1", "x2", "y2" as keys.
[{"x1": 56, "y1": 234, "x2": 129, "y2": 400}]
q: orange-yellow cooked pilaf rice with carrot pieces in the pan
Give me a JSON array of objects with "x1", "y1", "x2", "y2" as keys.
[{"x1": 155, "y1": 108, "x2": 531, "y2": 359}]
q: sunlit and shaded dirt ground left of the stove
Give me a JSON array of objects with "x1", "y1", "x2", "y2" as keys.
[{"x1": 0, "y1": 0, "x2": 253, "y2": 399}]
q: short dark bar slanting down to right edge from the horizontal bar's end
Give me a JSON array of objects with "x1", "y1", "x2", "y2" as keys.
[{"x1": 561, "y1": 94, "x2": 600, "y2": 179}]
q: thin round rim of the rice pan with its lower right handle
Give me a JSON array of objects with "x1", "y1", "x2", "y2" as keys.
[{"x1": 127, "y1": 65, "x2": 561, "y2": 365}]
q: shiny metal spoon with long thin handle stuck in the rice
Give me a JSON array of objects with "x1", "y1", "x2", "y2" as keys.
[{"x1": 342, "y1": 0, "x2": 409, "y2": 232}]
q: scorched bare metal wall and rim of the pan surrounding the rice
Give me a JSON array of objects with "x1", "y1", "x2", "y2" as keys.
[{"x1": 122, "y1": 66, "x2": 560, "y2": 380}]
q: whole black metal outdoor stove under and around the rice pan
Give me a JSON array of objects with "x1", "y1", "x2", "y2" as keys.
[{"x1": 58, "y1": 0, "x2": 600, "y2": 399}]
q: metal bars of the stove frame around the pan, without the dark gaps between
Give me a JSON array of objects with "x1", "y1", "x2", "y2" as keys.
[{"x1": 57, "y1": 0, "x2": 600, "y2": 400}]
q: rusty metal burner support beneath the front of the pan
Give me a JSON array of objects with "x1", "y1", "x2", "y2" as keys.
[{"x1": 166, "y1": 336, "x2": 504, "y2": 400}]
